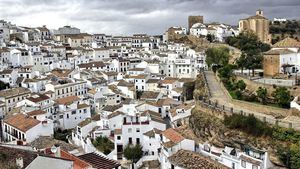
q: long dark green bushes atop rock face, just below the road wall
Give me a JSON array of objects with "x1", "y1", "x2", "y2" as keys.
[{"x1": 224, "y1": 114, "x2": 272, "y2": 136}]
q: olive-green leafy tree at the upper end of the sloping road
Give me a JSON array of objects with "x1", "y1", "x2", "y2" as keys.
[{"x1": 205, "y1": 47, "x2": 230, "y2": 67}]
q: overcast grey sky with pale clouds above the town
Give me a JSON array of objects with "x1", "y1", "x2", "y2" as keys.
[{"x1": 0, "y1": 0, "x2": 300, "y2": 35}]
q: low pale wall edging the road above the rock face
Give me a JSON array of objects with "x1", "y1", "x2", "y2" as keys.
[{"x1": 200, "y1": 99, "x2": 300, "y2": 130}]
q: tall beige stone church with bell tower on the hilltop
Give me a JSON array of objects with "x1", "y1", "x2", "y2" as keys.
[{"x1": 239, "y1": 10, "x2": 271, "y2": 43}]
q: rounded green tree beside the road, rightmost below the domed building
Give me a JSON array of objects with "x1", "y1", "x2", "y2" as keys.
[{"x1": 272, "y1": 87, "x2": 292, "y2": 108}]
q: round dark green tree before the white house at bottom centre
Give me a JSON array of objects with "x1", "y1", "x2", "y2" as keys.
[{"x1": 123, "y1": 144, "x2": 143, "y2": 168}]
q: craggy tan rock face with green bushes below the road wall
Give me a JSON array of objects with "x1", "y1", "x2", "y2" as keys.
[{"x1": 189, "y1": 101, "x2": 300, "y2": 169}]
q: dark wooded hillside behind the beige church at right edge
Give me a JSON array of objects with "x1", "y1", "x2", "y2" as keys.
[{"x1": 270, "y1": 20, "x2": 300, "y2": 44}]
